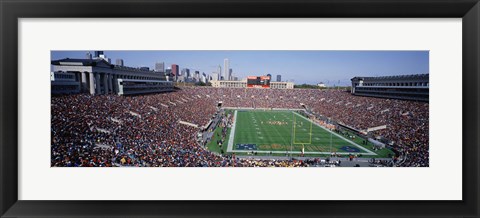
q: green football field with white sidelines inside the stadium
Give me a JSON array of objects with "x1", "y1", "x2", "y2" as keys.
[{"x1": 227, "y1": 110, "x2": 377, "y2": 157}]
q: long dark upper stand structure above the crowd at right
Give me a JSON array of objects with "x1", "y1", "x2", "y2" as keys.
[{"x1": 351, "y1": 74, "x2": 429, "y2": 102}]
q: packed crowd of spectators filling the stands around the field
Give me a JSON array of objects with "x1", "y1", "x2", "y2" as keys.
[{"x1": 51, "y1": 87, "x2": 429, "y2": 167}]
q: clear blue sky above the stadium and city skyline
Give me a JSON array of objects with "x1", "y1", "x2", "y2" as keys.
[{"x1": 51, "y1": 50, "x2": 429, "y2": 86}]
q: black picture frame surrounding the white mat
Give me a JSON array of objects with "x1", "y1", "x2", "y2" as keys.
[{"x1": 0, "y1": 0, "x2": 480, "y2": 217}]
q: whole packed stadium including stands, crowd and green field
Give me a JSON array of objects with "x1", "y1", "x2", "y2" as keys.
[{"x1": 51, "y1": 53, "x2": 429, "y2": 167}]
